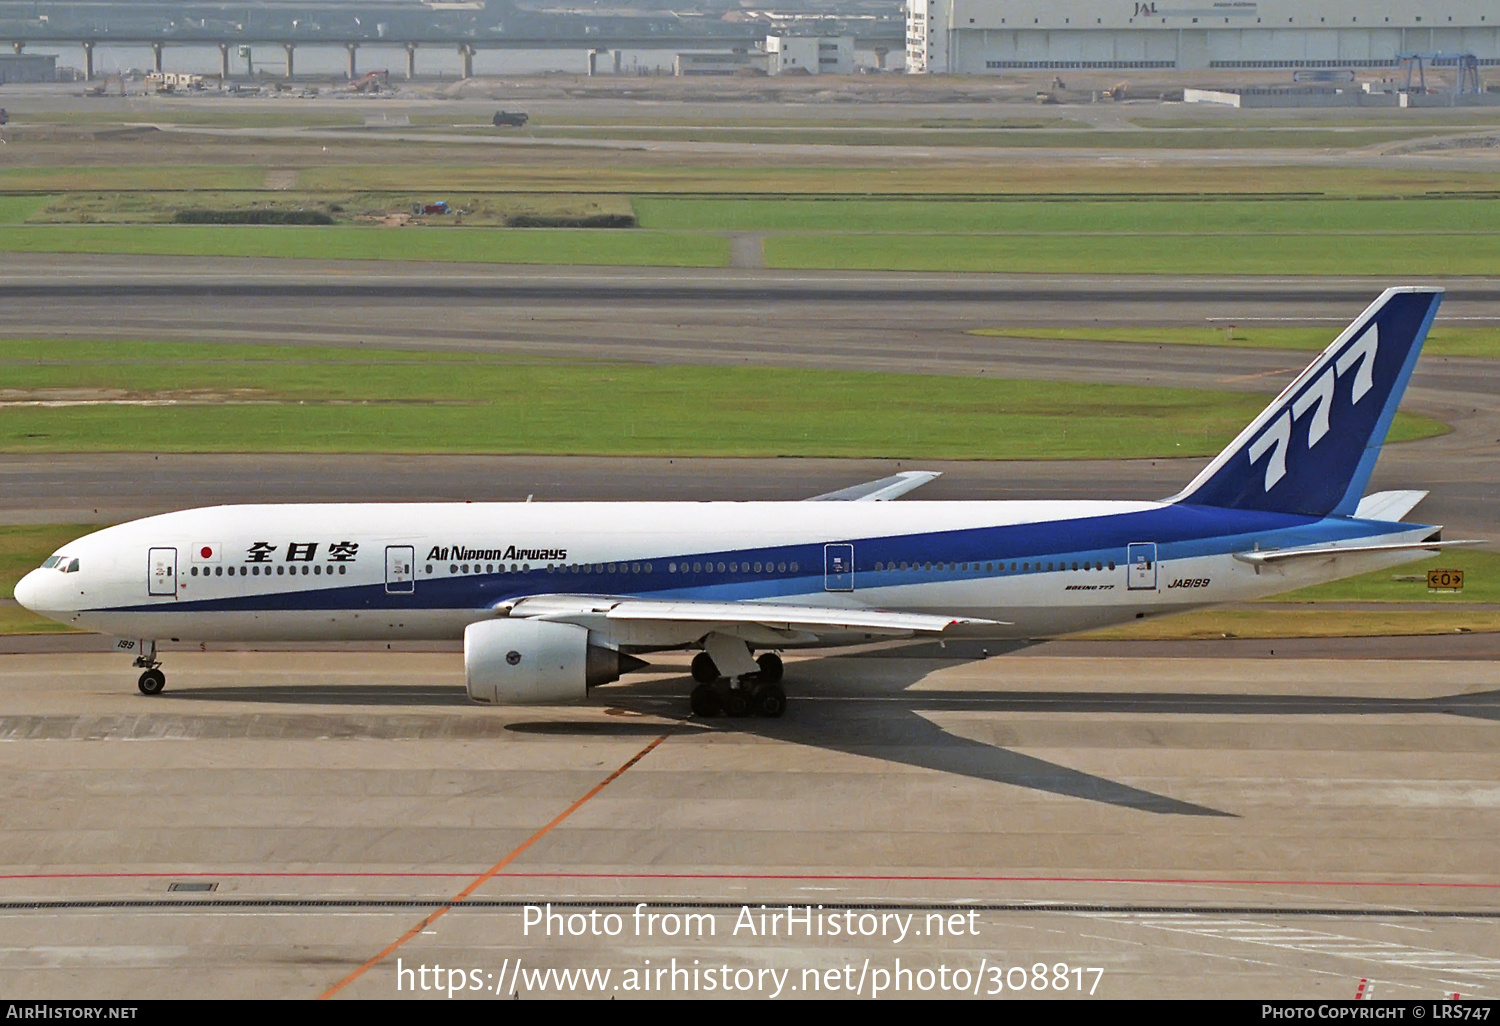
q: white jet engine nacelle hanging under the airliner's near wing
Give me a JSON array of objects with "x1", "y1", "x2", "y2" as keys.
[{"x1": 464, "y1": 620, "x2": 644, "y2": 705}]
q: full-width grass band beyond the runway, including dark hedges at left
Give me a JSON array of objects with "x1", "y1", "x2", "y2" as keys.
[{"x1": 0, "y1": 191, "x2": 1500, "y2": 275}]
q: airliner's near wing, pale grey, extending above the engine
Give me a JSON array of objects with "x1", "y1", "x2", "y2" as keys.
[{"x1": 498, "y1": 596, "x2": 1002, "y2": 636}]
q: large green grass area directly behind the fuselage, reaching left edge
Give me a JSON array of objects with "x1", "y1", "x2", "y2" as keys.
[{"x1": 0, "y1": 341, "x2": 1445, "y2": 459}]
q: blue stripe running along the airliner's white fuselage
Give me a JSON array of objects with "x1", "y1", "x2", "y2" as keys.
[{"x1": 90, "y1": 504, "x2": 1422, "y2": 612}]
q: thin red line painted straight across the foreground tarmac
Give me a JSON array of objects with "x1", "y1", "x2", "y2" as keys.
[{"x1": 11, "y1": 872, "x2": 1500, "y2": 890}]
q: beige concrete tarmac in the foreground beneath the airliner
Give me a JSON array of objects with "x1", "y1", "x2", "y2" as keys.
[{"x1": 0, "y1": 641, "x2": 1500, "y2": 998}]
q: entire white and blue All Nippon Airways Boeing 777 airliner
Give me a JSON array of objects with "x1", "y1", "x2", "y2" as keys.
[{"x1": 15, "y1": 288, "x2": 1466, "y2": 716}]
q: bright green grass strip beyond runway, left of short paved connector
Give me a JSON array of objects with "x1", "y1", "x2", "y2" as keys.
[{"x1": 0, "y1": 225, "x2": 729, "y2": 267}]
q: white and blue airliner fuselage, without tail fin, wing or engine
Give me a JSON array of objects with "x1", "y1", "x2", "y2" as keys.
[{"x1": 17, "y1": 501, "x2": 1431, "y2": 650}]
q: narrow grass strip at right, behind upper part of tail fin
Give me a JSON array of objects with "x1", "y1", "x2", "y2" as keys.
[{"x1": 971, "y1": 324, "x2": 1500, "y2": 360}]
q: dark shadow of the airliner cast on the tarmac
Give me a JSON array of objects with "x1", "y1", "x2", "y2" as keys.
[{"x1": 153, "y1": 650, "x2": 1500, "y2": 818}]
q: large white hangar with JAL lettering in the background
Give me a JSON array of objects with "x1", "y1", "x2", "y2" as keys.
[{"x1": 906, "y1": 0, "x2": 1500, "y2": 75}]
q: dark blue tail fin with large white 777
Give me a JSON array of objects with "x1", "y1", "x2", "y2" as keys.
[{"x1": 1167, "y1": 287, "x2": 1443, "y2": 516}]
